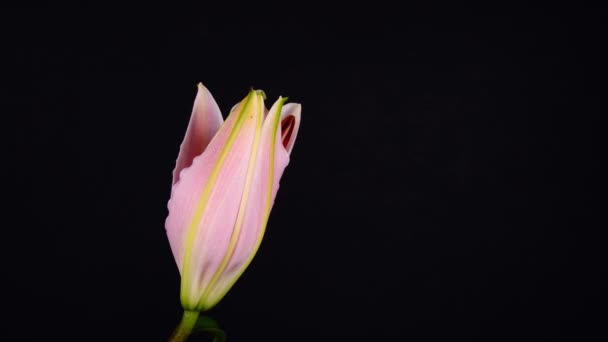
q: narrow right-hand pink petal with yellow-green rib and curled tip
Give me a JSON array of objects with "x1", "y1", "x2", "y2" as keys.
[{"x1": 205, "y1": 99, "x2": 301, "y2": 307}]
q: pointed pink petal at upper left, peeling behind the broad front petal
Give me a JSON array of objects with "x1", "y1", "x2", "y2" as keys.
[{"x1": 172, "y1": 83, "x2": 224, "y2": 184}]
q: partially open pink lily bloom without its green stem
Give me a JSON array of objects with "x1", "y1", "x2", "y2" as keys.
[{"x1": 165, "y1": 84, "x2": 301, "y2": 311}]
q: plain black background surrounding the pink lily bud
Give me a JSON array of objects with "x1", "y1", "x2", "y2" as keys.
[{"x1": 1, "y1": 7, "x2": 605, "y2": 341}]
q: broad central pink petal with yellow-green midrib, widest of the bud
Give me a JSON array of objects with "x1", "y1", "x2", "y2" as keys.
[{"x1": 166, "y1": 89, "x2": 262, "y2": 308}]
